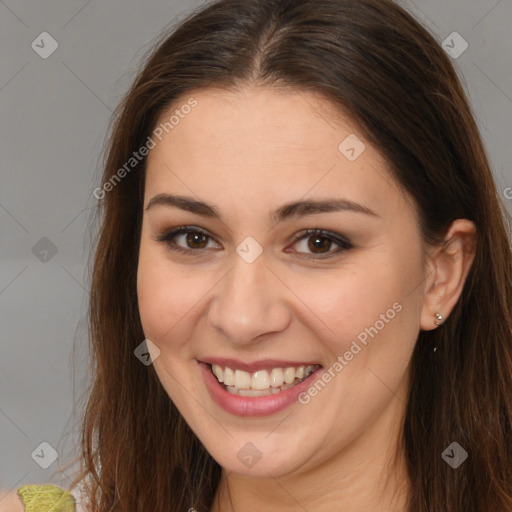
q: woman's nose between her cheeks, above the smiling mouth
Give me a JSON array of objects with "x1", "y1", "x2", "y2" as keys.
[{"x1": 208, "y1": 253, "x2": 291, "y2": 345}]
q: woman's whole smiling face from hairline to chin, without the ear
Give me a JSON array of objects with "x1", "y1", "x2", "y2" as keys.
[{"x1": 138, "y1": 88, "x2": 428, "y2": 477}]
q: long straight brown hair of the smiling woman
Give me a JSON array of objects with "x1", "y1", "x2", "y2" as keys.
[{"x1": 65, "y1": 0, "x2": 512, "y2": 512}]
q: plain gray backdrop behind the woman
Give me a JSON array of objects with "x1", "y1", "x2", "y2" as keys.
[{"x1": 0, "y1": 0, "x2": 512, "y2": 509}]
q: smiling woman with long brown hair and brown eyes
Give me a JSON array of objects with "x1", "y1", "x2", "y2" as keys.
[{"x1": 8, "y1": 0, "x2": 512, "y2": 512}]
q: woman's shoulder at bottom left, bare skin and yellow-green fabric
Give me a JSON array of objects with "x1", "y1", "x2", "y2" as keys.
[{"x1": 0, "y1": 484, "x2": 77, "y2": 512}]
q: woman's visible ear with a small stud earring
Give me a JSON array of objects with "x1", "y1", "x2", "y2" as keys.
[{"x1": 420, "y1": 219, "x2": 476, "y2": 331}]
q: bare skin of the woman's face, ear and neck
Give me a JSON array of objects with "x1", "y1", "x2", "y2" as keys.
[{"x1": 137, "y1": 85, "x2": 475, "y2": 512}]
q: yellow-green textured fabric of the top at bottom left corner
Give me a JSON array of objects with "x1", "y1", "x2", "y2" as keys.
[{"x1": 17, "y1": 484, "x2": 76, "y2": 512}]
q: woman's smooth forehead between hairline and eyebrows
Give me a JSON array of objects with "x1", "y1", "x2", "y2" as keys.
[{"x1": 145, "y1": 87, "x2": 412, "y2": 222}]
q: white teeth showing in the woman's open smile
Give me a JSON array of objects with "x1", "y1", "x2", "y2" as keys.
[{"x1": 210, "y1": 364, "x2": 321, "y2": 397}]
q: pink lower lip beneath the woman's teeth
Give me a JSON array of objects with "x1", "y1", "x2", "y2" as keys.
[{"x1": 199, "y1": 361, "x2": 322, "y2": 416}]
